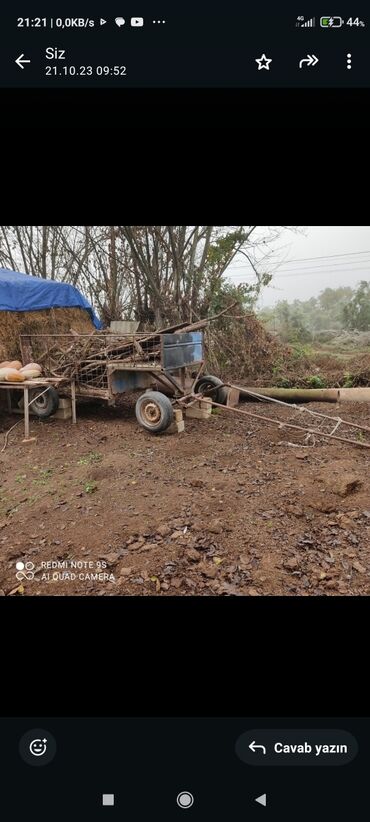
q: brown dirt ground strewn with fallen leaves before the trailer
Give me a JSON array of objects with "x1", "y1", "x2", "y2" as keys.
[{"x1": 0, "y1": 396, "x2": 370, "y2": 596}]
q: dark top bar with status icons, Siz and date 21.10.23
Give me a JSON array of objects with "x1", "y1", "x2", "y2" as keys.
[{"x1": 0, "y1": 0, "x2": 370, "y2": 89}]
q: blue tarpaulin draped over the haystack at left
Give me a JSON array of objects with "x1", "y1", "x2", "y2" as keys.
[{"x1": 0, "y1": 268, "x2": 102, "y2": 328}]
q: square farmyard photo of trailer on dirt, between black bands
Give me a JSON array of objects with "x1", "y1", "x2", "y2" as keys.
[{"x1": 0, "y1": 225, "x2": 370, "y2": 598}]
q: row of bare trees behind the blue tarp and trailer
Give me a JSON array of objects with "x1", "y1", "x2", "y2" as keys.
[{"x1": 0, "y1": 226, "x2": 300, "y2": 327}]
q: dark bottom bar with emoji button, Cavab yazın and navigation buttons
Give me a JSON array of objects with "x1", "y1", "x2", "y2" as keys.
[{"x1": 0, "y1": 717, "x2": 370, "y2": 822}]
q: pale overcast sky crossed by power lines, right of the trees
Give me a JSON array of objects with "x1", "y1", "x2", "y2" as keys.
[{"x1": 228, "y1": 226, "x2": 370, "y2": 308}]
